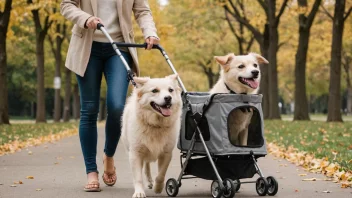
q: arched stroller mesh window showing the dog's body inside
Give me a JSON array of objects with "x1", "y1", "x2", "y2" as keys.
[{"x1": 227, "y1": 106, "x2": 264, "y2": 147}]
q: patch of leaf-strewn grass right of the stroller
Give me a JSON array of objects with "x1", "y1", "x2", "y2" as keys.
[{"x1": 265, "y1": 120, "x2": 352, "y2": 170}]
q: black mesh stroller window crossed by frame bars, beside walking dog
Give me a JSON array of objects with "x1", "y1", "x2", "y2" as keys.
[{"x1": 185, "y1": 111, "x2": 210, "y2": 141}]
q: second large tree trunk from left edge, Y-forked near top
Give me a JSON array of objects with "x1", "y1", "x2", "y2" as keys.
[{"x1": 27, "y1": 0, "x2": 53, "y2": 122}]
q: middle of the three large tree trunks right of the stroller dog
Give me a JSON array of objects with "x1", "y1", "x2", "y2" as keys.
[{"x1": 293, "y1": 0, "x2": 321, "y2": 120}]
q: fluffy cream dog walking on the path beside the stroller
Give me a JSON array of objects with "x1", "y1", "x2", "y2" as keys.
[{"x1": 122, "y1": 75, "x2": 182, "y2": 197}]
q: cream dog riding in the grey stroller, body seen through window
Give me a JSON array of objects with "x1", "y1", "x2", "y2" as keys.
[{"x1": 210, "y1": 53, "x2": 269, "y2": 146}]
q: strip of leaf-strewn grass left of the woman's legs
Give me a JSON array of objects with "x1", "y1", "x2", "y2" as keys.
[{"x1": 0, "y1": 122, "x2": 78, "y2": 145}]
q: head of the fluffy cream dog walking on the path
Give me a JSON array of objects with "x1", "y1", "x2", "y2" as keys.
[{"x1": 134, "y1": 75, "x2": 181, "y2": 117}]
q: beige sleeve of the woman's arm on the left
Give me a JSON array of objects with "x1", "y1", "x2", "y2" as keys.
[{"x1": 60, "y1": 0, "x2": 91, "y2": 28}]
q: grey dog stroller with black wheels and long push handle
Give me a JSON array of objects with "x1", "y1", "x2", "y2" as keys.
[{"x1": 98, "y1": 24, "x2": 278, "y2": 198}]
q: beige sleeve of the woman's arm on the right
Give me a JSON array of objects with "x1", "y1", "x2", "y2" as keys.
[{"x1": 132, "y1": 0, "x2": 159, "y2": 39}]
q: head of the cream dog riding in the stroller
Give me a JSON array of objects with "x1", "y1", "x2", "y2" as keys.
[{"x1": 215, "y1": 53, "x2": 269, "y2": 93}]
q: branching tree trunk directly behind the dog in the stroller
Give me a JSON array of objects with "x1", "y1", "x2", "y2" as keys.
[{"x1": 223, "y1": 0, "x2": 288, "y2": 119}]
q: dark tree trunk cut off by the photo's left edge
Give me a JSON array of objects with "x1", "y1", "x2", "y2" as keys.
[{"x1": 0, "y1": 0, "x2": 12, "y2": 124}]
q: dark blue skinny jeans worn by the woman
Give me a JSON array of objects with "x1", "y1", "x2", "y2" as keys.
[{"x1": 77, "y1": 42, "x2": 132, "y2": 174}]
